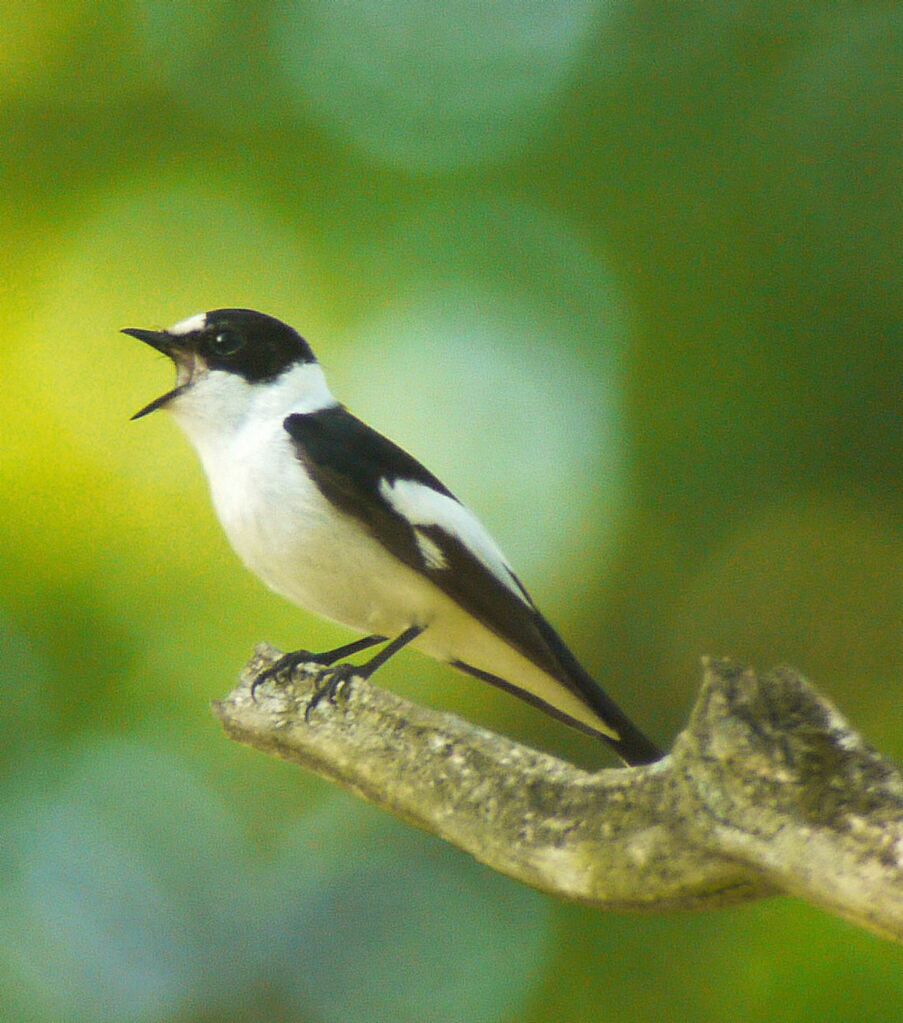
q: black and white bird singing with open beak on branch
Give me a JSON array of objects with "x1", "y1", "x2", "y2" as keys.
[{"x1": 124, "y1": 309, "x2": 661, "y2": 764}]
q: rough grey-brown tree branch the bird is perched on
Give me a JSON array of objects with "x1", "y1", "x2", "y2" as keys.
[{"x1": 214, "y1": 646, "x2": 903, "y2": 941}]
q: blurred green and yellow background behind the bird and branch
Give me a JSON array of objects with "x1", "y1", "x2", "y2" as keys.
[{"x1": 0, "y1": 0, "x2": 903, "y2": 1023}]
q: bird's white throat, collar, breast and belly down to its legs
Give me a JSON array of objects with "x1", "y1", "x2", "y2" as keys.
[{"x1": 173, "y1": 364, "x2": 445, "y2": 635}]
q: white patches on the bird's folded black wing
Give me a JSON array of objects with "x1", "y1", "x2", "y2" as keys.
[{"x1": 379, "y1": 480, "x2": 530, "y2": 606}]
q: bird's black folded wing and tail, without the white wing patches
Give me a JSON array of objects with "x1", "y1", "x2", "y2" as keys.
[{"x1": 283, "y1": 405, "x2": 660, "y2": 763}]
